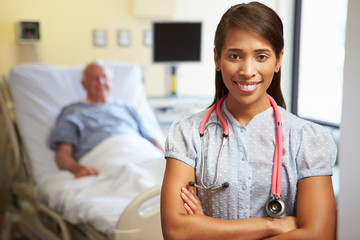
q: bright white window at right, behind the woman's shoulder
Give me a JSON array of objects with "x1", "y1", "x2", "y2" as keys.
[{"x1": 292, "y1": 0, "x2": 347, "y2": 126}]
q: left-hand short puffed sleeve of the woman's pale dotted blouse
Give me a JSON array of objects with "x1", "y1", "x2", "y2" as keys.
[{"x1": 165, "y1": 115, "x2": 200, "y2": 167}]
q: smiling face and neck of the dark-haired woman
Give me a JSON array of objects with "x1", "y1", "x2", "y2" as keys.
[{"x1": 215, "y1": 28, "x2": 283, "y2": 108}]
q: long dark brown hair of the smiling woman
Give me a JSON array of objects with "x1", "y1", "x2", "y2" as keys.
[{"x1": 214, "y1": 2, "x2": 286, "y2": 108}]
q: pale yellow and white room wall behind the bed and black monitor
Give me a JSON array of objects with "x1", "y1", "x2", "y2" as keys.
[{"x1": 0, "y1": 0, "x2": 294, "y2": 102}]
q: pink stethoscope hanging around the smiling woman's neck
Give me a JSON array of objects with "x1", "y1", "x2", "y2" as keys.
[{"x1": 188, "y1": 95, "x2": 285, "y2": 218}]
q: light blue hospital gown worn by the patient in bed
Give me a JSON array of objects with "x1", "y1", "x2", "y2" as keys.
[{"x1": 49, "y1": 99, "x2": 156, "y2": 160}]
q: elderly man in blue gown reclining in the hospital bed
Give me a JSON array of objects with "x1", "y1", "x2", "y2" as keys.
[{"x1": 50, "y1": 62, "x2": 164, "y2": 178}]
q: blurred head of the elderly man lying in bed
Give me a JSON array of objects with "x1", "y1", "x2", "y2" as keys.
[{"x1": 83, "y1": 64, "x2": 112, "y2": 103}]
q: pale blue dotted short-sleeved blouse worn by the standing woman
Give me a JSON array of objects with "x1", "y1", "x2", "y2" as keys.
[{"x1": 165, "y1": 102, "x2": 337, "y2": 219}]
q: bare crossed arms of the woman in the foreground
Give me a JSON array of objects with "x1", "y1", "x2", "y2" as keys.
[{"x1": 161, "y1": 159, "x2": 336, "y2": 239}]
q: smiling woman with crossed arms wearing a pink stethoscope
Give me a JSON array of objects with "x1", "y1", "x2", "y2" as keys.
[{"x1": 161, "y1": 2, "x2": 336, "y2": 239}]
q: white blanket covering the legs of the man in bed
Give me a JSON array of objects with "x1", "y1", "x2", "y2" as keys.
[{"x1": 36, "y1": 136, "x2": 165, "y2": 236}]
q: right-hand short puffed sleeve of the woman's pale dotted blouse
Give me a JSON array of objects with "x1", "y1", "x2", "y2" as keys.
[{"x1": 297, "y1": 123, "x2": 337, "y2": 179}]
